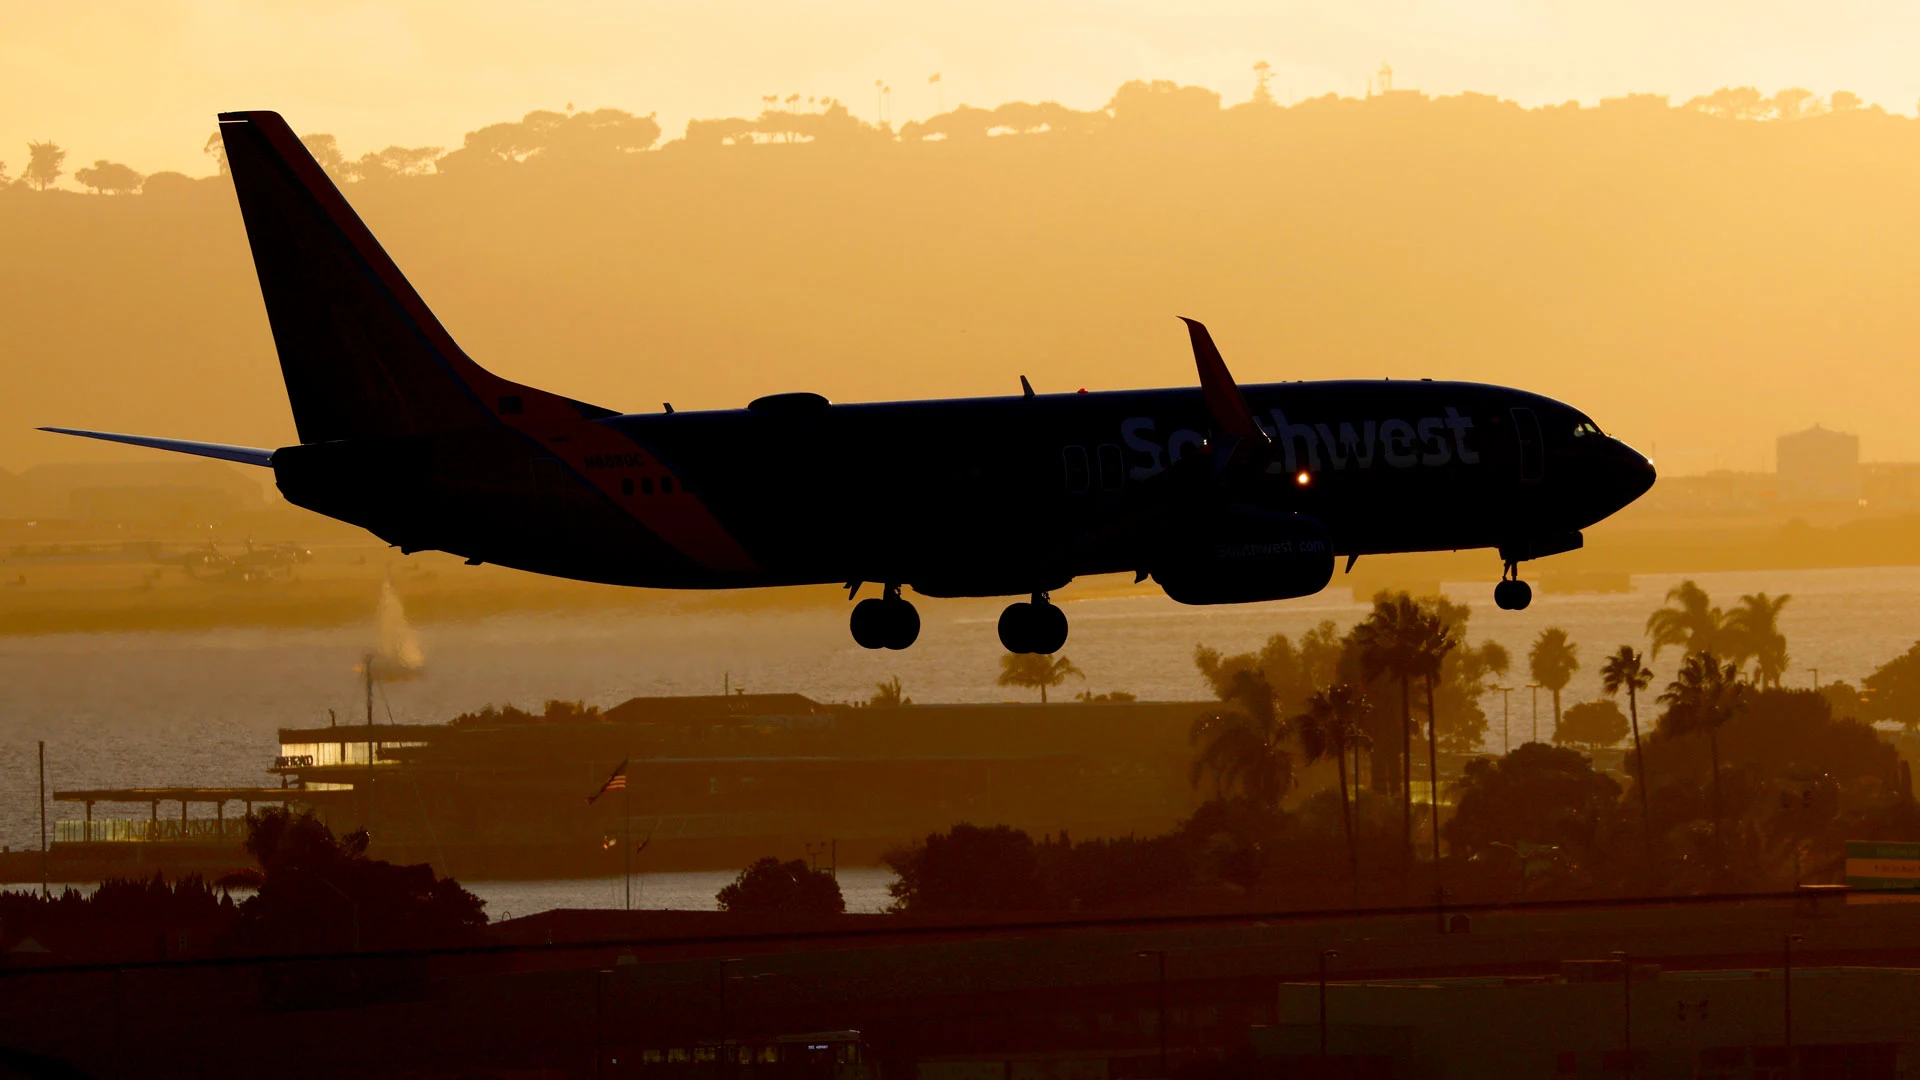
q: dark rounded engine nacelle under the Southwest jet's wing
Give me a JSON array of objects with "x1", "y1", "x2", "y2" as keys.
[{"x1": 1152, "y1": 511, "x2": 1332, "y2": 603}]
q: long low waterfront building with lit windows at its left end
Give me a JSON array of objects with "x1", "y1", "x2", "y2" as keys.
[{"x1": 37, "y1": 694, "x2": 1206, "y2": 880}]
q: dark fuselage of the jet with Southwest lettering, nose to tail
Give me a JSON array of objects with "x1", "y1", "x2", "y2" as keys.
[{"x1": 275, "y1": 380, "x2": 1651, "y2": 596}]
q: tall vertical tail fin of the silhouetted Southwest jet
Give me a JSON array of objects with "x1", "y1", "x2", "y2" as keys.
[{"x1": 221, "y1": 111, "x2": 611, "y2": 442}]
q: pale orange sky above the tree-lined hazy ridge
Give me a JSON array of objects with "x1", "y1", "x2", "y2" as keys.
[{"x1": 0, "y1": 0, "x2": 1920, "y2": 175}]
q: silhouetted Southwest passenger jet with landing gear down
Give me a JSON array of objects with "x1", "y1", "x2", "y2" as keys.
[{"x1": 42, "y1": 111, "x2": 1655, "y2": 653}]
